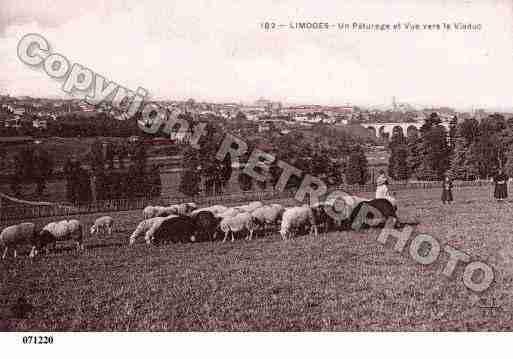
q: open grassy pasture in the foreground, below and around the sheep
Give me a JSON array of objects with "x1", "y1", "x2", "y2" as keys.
[{"x1": 0, "y1": 187, "x2": 513, "y2": 331}]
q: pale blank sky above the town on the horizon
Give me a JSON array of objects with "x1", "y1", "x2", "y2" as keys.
[{"x1": 0, "y1": 0, "x2": 513, "y2": 108}]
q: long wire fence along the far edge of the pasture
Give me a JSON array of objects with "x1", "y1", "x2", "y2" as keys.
[{"x1": 0, "y1": 180, "x2": 491, "y2": 221}]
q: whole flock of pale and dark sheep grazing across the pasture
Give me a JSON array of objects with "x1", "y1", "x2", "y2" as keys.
[{"x1": 0, "y1": 196, "x2": 395, "y2": 259}]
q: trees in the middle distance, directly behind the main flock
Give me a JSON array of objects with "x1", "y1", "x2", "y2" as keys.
[{"x1": 180, "y1": 123, "x2": 369, "y2": 196}]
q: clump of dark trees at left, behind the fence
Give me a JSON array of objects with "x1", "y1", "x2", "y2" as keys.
[{"x1": 10, "y1": 141, "x2": 162, "y2": 204}]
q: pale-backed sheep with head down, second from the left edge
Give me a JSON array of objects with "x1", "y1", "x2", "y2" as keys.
[{"x1": 31, "y1": 219, "x2": 84, "y2": 256}]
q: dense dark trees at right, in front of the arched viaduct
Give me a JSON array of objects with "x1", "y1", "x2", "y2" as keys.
[{"x1": 388, "y1": 113, "x2": 513, "y2": 180}]
